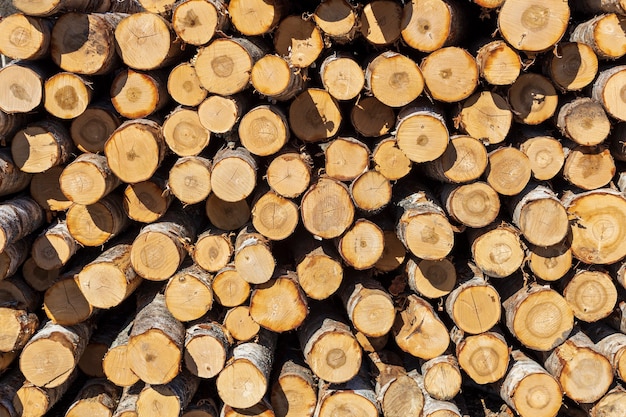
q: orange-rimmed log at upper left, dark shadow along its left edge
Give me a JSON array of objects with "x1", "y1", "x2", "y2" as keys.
[{"x1": 110, "y1": 68, "x2": 169, "y2": 119}]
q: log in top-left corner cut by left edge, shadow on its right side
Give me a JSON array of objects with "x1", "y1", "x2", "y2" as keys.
[{"x1": 0, "y1": 13, "x2": 53, "y2": 60}]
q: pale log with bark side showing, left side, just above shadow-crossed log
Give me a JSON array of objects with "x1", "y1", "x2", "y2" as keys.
[{"x1": 59, "y1": 153, "x2": 120, "y2": 205}]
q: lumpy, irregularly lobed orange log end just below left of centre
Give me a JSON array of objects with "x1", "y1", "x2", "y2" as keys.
[{"x1": 250, "y1": 271, "x2": 309, "y2": 333}]
